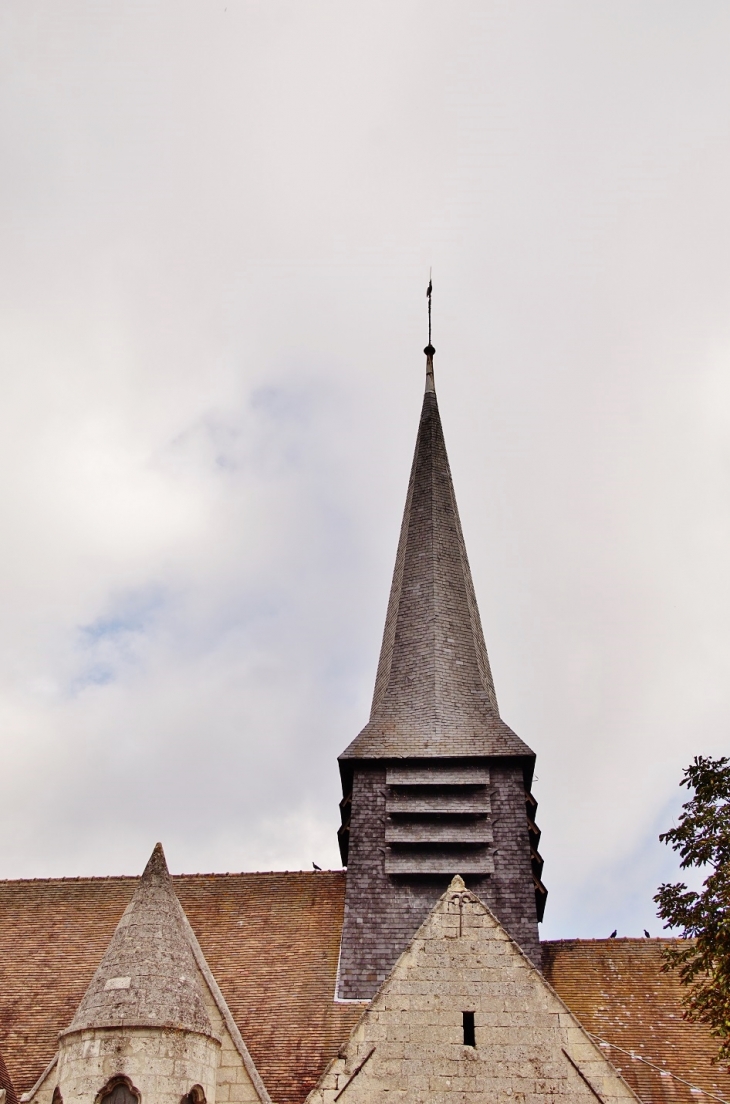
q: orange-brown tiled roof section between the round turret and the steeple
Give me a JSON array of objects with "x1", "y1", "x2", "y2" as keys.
[{"x1": 174, "y1": 871, "x2": 362, "y2": 1104}]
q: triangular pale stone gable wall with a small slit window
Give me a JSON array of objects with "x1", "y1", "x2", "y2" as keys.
[{"x1": 307, "y1": 878, "x2": 637, "y2": 1104}]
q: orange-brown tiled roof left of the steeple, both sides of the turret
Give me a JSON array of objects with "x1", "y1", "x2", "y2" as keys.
[{"x1": 0, "y1": 871, "x2": 361, "y2": 1104}]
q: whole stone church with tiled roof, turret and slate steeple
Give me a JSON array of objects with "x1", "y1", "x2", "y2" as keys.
[{"x1": 0, "y1": 342, "x2": 730, "y2": 1104}]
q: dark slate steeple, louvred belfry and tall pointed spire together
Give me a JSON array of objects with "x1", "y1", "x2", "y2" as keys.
[{"x1": 338, "y1": 344, "x2": 547, "y2": 999}]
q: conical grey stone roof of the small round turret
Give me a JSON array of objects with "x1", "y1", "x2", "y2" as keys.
[{"x1": 67, "y1": 843, "x2": 213, "y2": 1036}]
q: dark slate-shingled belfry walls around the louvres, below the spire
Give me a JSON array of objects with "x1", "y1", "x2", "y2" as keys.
[{"x1": 337, "y1": 761, "x2": 540, "y2": 1000}]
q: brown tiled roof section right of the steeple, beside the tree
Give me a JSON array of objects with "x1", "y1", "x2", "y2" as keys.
[{"x1": 542, "y1": 940, "x2": 730, "y2": 1104}]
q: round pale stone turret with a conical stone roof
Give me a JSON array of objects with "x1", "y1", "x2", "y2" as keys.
[{"x1": 57, "y1": 843, "x2": 220, "y2": 1104}]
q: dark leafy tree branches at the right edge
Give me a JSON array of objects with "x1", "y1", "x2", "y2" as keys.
[{"x1": 654, "y1": 755, "x2": 730, "y2": 1061}]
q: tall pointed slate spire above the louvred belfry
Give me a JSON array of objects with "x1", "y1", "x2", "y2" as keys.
[{"x1": 340, "y1": 346, "x2": 535, "y2": 761}]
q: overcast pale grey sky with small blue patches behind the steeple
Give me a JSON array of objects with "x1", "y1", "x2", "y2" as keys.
[{"x1": 0, "y1": 0, "x2": 730, "y2": 937}]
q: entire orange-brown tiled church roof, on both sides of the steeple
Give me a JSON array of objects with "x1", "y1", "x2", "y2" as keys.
[{"x1": 0, "y1": 871, "x2": 730, "y2": 1104}]
